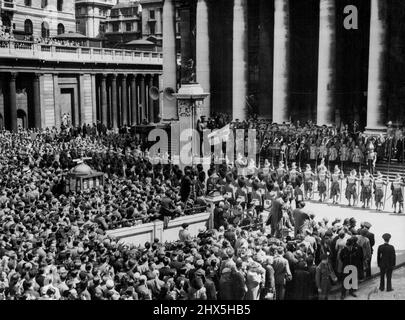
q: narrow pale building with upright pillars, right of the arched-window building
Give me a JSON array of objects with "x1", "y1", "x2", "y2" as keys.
[{"x1": 75, "y1": 0, "x2": 117, "y2": 38}]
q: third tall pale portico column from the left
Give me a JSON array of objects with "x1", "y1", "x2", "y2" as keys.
[{"x1": 232, "y1": 0, "x2": 248, "y2": 121}]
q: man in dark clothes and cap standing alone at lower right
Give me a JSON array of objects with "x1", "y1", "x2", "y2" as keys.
[{"x1": 377, "y1": 233, "x2": 396, "y2": 292}]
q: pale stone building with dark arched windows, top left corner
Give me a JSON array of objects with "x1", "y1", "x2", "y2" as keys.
[{"x1": 0, "y1": 0, "x2": 76, "y2": 38}]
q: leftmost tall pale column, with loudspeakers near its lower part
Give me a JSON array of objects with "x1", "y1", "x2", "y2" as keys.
[{"x1": 163, "y1": 0, "x2": 178, "y2": 119}]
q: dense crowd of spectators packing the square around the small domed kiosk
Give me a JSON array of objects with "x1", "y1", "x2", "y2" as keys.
[{"x1": 0, "y1": 124, "x2": 395, "y2": 300}]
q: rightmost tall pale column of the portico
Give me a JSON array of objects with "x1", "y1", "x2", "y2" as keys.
[{"x1": 367, "y1": 0, "x2": 388, "y2": 131}]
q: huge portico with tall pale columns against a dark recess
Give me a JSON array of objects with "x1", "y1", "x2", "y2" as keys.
[{"x1": 162, "y1": 0, "x2": 405, "y2": 130}]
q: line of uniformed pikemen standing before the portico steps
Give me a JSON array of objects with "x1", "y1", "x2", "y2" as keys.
[{"x1": 207, "y1": 154, "x2": 405, "y2": 213}]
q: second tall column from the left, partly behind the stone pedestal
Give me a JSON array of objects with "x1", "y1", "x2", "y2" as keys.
[{"x1": 196, "y1": 0, "x2": 211, "y2": 117}]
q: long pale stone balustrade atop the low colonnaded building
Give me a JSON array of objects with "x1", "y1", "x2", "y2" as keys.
[{"x1": 0, "y1": 40, "x2": 163, "y2": 66}]
